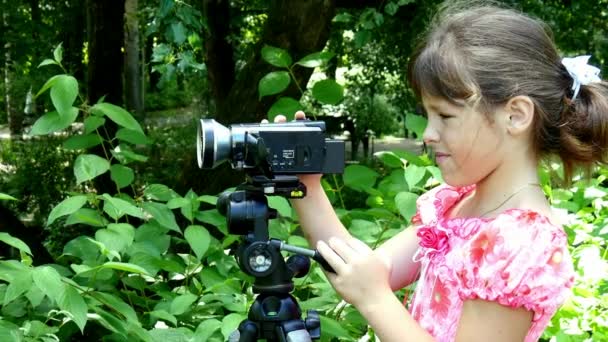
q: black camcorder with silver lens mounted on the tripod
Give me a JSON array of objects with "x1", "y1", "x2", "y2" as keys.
[{"x1": 197, "y1": 119, "x2": 345, "y2": 179}]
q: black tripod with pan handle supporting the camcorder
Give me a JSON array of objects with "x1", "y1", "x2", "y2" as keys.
[{"x1": 217, "y1": 176, "x2": 333, "y2": 342}]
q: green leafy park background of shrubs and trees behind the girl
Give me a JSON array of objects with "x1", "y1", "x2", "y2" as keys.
[{"x1": 0, "y1": 0, "x2": 608, "y2": 342}]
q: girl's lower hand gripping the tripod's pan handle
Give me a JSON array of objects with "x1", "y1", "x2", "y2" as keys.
[{"x1": 317, "y1": 238, "x2": 392, "y2": 310}]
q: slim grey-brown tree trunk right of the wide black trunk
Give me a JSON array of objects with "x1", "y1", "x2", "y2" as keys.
[{"x1": 125, "y1": 0, "x2": 144, "y2": 121}]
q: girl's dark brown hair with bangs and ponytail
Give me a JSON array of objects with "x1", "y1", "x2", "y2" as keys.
[{"x1": 408, "y1": 1, "x2": 608, "y2": 182}]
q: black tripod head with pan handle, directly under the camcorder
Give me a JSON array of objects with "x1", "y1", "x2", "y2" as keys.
[{"x1": 217, "y1": 176, "x2": 333, "y2": 293}]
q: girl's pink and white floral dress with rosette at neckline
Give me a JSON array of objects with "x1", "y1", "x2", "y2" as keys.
[{"x1": 409, "y1": 185, "x2": 574, "y2": 342}]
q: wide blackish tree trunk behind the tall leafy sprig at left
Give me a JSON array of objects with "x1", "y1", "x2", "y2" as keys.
[{"x1": 87, "y1": 0, "x2": 125, "y2": 194}]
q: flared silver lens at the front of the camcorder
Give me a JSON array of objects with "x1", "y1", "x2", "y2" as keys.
[{"x1": 196, "y1": 119, "x2": 231, "y2": 169}]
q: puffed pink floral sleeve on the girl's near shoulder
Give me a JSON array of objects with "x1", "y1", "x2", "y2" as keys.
[{"x1": 457, "y1": 209, "x2": 574, "y2": 324}]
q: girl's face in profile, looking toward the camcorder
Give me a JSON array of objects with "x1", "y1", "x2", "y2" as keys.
[{"x1": 422, "y1": 97, "x2": 508, "y2": 186}]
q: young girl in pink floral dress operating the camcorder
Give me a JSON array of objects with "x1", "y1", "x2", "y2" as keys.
[{"x1": 278, "y1": 2, "x2": 608, "y2": 342}]
